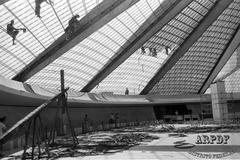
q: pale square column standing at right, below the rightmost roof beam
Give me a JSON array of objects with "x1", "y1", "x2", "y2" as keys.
[{"x1": 211, "y1": 81, "x2": 228, "y2": 122}]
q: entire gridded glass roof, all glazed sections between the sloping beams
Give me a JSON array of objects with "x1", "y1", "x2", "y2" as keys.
[{"x1": 0, "y1": 0, "x2": 240, "y2": 95}]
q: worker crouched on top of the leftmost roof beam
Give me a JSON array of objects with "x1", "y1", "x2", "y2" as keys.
[{"x1": 65, "y1": 15, "x2": 80, "y2": 40}]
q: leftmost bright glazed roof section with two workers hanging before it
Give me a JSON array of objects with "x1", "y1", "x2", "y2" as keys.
[{"x1": 0, "y1": 0, "x2": 102, "y2": 78}]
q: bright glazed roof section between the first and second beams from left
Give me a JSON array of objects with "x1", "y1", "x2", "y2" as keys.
[{"x1": 27, "y1": 0, "x2": 170, "y2": 90}]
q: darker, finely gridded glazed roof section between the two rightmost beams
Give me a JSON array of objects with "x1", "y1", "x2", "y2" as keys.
[{"x1": 151, "y1": 1, "x2": 240, "y2": 95}]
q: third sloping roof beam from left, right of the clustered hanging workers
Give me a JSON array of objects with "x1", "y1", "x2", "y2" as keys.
[{"x1": 140, "y1": 0, "x2": 232, "y2": 94}]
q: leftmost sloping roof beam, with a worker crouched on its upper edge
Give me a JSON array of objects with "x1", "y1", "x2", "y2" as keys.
[{"x1": 13, "y1": 0, "x2": 139, "y2": 82}]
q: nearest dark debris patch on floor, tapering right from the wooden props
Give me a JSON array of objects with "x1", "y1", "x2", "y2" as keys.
[{"x1": 8, "y1": 132, "x2": 159, "y2": 159}]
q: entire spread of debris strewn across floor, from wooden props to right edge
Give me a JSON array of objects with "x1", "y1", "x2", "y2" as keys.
[{"x1": 4, "y1": 123, "x2": 240, "y2": 159}]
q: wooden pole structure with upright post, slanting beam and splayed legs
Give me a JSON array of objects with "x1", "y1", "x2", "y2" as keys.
[{"x1": 0, "y1": 70, "x2": 78, "y2": 159}]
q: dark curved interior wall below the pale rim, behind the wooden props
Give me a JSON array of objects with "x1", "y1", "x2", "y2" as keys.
[{"x1": 0, "y1": 105, "x2": 156, "y2": 128}]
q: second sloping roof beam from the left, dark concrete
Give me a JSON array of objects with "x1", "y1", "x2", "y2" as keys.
[{"x1": 81, "y1": 0, "x2": 192, "y2": 92}]
